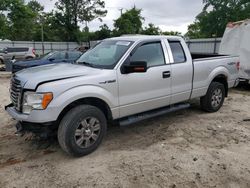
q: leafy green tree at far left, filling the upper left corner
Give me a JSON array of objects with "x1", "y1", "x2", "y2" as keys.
[{"x1": 0, "y1": 0, "x2": 43, "y2": 40}]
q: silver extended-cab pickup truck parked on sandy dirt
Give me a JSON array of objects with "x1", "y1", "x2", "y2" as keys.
[{"x1": 5, "y1": 36, "x2": 240, "y2": 156}]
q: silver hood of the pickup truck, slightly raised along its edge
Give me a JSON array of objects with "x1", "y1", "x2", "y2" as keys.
[{"x1": 15, "y1": 63, "x2": 102, "y2": 89}]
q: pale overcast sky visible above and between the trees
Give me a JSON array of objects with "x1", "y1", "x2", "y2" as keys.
[{"x1": 37, "y1": 0, "x2": 203, "y2": 34}]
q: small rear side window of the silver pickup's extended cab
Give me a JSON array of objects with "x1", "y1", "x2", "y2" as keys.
[{"x1": 169, "y1": 41, "x2": 186, "y2": 63}]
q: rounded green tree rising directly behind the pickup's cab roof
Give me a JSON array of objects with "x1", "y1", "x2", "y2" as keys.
[{"x1": 114, "y1": 7, "x2": 144, "y2": 35}]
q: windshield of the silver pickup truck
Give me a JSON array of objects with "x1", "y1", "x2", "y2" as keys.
[{"x1": 76, "y1": 40, "x2": 132, "y2": 69}]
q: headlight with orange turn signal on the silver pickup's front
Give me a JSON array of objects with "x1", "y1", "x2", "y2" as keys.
[{"x1": 23, "y1": 91, "x2": 53, "y2": 114}]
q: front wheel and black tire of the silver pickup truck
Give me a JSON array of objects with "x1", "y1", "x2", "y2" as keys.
[{"x1": 57, "y1": 105, "x2": 107, "y2": 157}]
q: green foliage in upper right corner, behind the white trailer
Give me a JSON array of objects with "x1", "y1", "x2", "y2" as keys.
[{"x1": 186, "y1": 0, "x2": 250, "y2": 38}]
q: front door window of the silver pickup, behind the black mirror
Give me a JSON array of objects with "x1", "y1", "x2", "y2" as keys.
[{"x1": 130, "y1": 42, "x2": 165, "y2": 67}]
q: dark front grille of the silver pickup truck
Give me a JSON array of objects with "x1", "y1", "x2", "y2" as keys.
[{"x1": 10, "y1": 76, "x2": 22, "y2": 111}]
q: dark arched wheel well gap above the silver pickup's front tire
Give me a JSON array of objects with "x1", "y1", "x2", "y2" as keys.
[{"x1": 57, "y1": 97, "x2": 113, "y2": 123}]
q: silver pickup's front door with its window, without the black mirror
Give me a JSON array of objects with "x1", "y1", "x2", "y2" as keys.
[{"x1": 118, "y1": 41, "x2": 171, "y2": 117}]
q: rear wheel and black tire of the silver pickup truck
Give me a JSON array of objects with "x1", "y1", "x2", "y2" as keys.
[{"x1": 200, "y1": 82, "x2": 225, "y2": 112}]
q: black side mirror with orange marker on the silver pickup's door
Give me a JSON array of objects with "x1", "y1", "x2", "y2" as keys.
[{"x1": 122, "y1": 61, "x2": 147, "y2": 74}]
